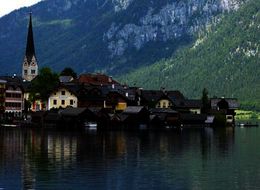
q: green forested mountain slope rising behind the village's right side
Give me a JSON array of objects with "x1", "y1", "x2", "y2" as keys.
[{"x1": 121, "y1": 1, "x2": 260, "y2": 110}]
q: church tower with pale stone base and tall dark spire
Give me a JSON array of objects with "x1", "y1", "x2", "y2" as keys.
[{"x1": 22, "y1": 13, "x2": 38, "y2": 81}]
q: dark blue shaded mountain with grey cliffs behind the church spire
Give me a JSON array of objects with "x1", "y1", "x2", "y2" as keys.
[{"x1": 0, "y1": 0, "x2": 244, "y2": 75}]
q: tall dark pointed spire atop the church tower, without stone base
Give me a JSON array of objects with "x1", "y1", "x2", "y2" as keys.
[{"x1": 26, "y1": 12, "x2": 35, "y2": 60}]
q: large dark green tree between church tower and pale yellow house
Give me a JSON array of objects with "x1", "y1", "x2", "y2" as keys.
[{"x1": 30, "y1": 67, "x2": 59, "y2": 101}]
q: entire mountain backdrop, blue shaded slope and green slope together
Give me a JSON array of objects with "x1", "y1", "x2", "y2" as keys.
[{"x1": 0, "y1": 0, "x2": 260, "y2": 109}]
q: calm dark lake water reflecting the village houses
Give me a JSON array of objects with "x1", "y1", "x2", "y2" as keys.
[{"x1": 0, "y1": 125, "x2": 260, "y2": 190}]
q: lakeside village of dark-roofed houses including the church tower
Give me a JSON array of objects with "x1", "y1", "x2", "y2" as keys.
[{"x1": 0, "y1": 14, "x2": 239, "y2": 130}]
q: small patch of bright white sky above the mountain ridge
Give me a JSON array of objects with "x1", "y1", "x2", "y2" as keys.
[{"x1": 0, "y1": 0, "x2": 41, "y2": 17}]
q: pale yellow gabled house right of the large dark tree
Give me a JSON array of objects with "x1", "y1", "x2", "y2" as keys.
[{"x1": 48, "y1": 85, "x2": 78, "y2": 110}]
